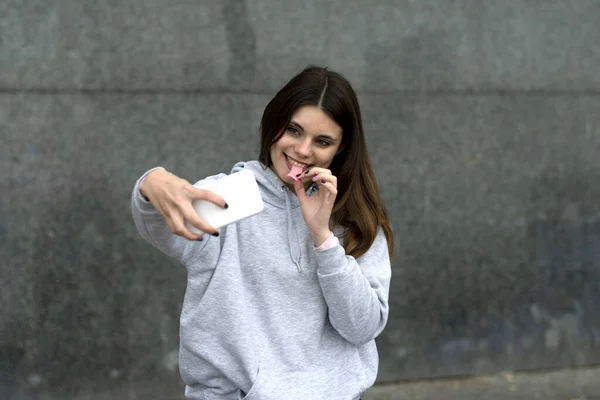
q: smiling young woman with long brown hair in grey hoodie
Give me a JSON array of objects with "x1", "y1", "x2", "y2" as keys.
[{"x1": 131, "y1": 67, "x2": 393, "y2": 400}]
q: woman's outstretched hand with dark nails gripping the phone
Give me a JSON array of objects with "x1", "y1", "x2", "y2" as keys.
[{"x1": 140, "y1": 168, "x2": 227, "y2": 240}]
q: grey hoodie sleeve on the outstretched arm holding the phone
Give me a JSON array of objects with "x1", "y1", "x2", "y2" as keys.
[{"x1": 131, "y1": 167, "x2": 220, "y2": 264}]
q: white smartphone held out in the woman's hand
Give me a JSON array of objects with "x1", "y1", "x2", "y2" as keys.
[{"x1": 186, "y1": 169, "x2": 264, "y2": 234}]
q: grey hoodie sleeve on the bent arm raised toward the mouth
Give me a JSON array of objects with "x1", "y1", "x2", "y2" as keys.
[{"x1": 316, "y1": 230, "x2": 392, "y2": 345}]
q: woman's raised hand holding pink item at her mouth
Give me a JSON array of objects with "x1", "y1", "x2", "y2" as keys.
[{"x1": 294, "y1": 167, "x2": 337, "y2": 246}]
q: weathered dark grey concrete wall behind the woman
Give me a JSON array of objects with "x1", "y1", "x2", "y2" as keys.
[{"x1": 0, "y1": 0, "x2": 600, "y2": 400}]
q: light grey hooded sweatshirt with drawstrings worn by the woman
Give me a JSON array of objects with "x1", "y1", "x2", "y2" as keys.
[{"x1": 131, "y1": 161, "x2": 391, "y2": 400}]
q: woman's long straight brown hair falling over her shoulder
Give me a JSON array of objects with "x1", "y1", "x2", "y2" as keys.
[{"x1": 259, "y1": 66, "x2": 394, "y2": 258}]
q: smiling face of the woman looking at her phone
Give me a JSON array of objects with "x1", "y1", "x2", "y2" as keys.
[{"x1": 271, "y1": 106, "x2": 342, "y2": 188}]
